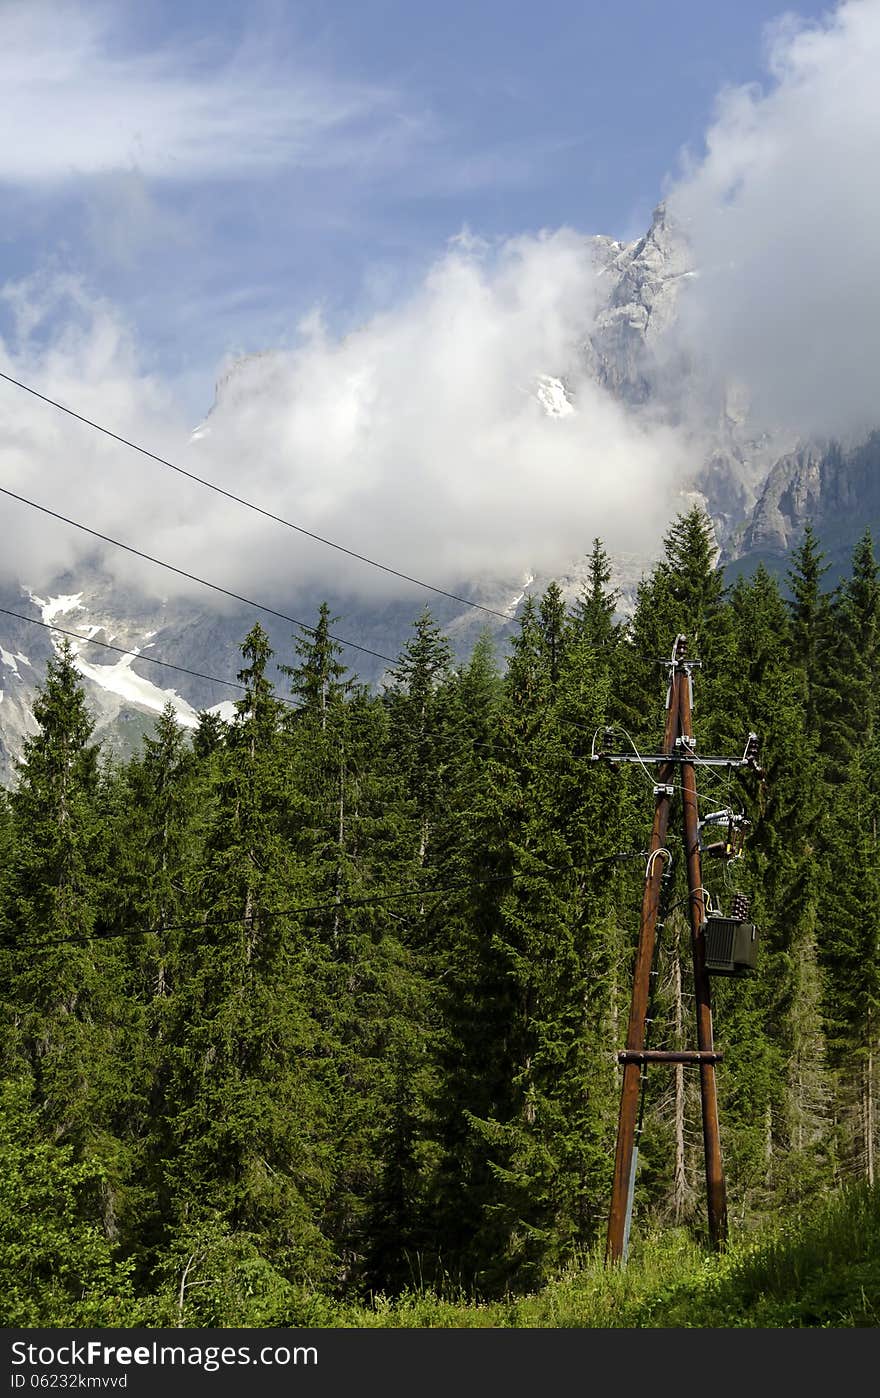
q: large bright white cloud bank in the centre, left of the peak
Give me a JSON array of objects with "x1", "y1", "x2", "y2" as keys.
[{"x1": 178, "y1": 229, "x2": 680, "y2": 593}]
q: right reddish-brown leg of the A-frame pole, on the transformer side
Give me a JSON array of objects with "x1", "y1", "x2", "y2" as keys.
[{"x1": 679, "y1": 662, "x2": 728, "y2": 1248}]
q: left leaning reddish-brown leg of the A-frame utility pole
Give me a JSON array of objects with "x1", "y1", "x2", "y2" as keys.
[{"x1": 604, "y1": 636, "x2": 686, "y2": 1262}]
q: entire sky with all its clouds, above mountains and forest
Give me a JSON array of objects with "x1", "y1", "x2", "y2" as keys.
[{"x1": 0, "y1": 0, "x2": 880, "y2": 597}]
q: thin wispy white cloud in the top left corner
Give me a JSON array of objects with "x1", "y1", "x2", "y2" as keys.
[{"x1": 0, "y1": 0, "x2": 413, "y2": 183}]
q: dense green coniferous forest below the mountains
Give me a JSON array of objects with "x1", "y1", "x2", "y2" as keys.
[{"x1": 0, "y1": 510, "x2": 880, "y2": 1325}]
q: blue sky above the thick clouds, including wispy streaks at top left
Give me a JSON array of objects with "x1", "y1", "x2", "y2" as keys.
[{"x1": 0, "y1": 0, "x2": 825, "y2": 410}]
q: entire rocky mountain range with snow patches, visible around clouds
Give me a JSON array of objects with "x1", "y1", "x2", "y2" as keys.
[{"x1": 0, "y1": 206, "x2": 880, "y2": 784}]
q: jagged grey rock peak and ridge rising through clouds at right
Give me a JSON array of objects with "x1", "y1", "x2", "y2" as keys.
[{"x1": 582, "y1": 204, "x2": 880, "y2": 573}]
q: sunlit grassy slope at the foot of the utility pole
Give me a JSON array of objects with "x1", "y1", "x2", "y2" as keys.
[{"x1": 330, "y1": 1187, "x2": 880, "y2": 1329}]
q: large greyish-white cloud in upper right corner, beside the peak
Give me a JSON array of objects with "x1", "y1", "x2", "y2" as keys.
[{"x1": 669, "y1": 0, "x2": 880, "y2": 435}]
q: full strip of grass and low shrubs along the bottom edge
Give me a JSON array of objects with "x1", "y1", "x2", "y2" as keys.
[{"x1": 22, "y1": 1186, "x2": 880, "y2": 1329}]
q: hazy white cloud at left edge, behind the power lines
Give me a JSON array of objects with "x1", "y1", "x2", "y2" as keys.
[{"x1": 0, "y1": 274, "x2": 195, "y2": 590}]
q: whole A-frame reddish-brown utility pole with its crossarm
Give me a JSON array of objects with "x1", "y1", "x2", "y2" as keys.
[{"x1": 604, "y1": 635, "x2": 760, "y2": 1262}]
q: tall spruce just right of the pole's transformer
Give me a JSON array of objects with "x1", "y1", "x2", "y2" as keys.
[{"x1": 707, "y1": 568, "x2": 827, "y2": 1211}]
